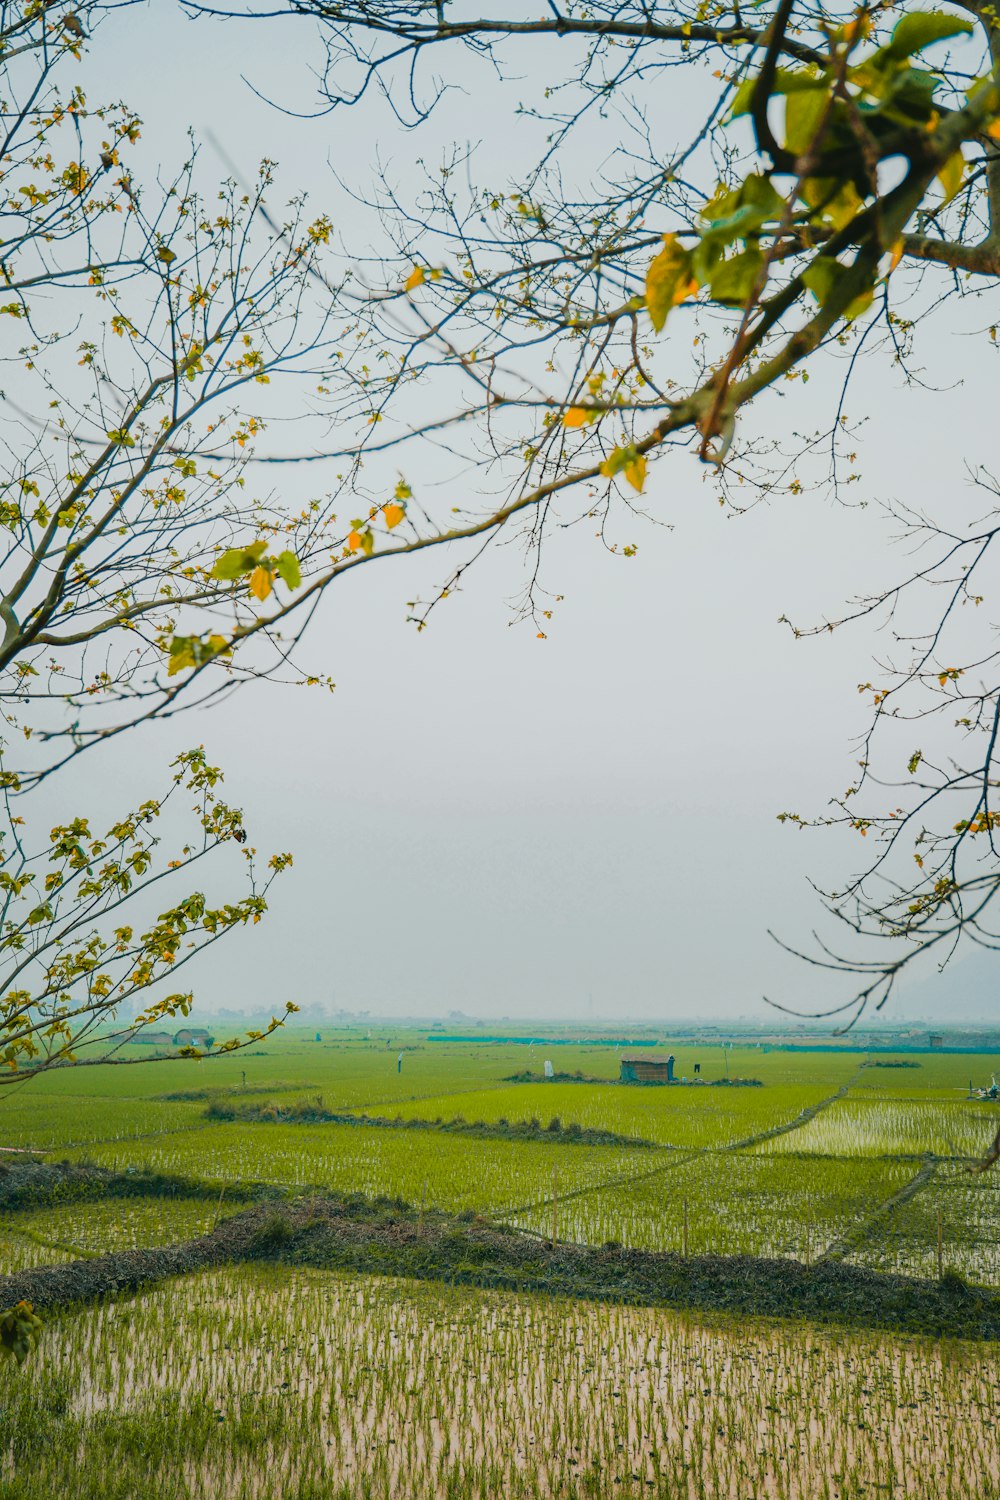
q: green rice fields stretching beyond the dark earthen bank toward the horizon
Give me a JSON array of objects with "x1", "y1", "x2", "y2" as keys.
[{"x1": 0, "y1": 1029, "x2": 1000, "y2": 1281}]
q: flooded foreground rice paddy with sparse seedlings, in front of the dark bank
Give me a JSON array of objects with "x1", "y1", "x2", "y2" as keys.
[{"x1": 0, "y1": 1268, "x2": 1000, "y2": 1500}]
